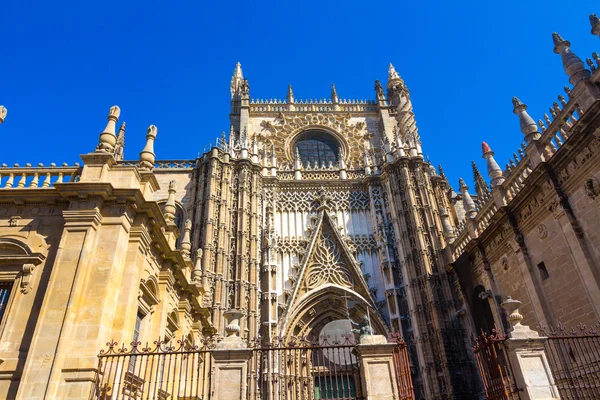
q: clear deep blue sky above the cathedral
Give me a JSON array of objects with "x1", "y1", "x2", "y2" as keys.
[{"x1": 0, "y1": 0, "x2": 600, "y2": 186}]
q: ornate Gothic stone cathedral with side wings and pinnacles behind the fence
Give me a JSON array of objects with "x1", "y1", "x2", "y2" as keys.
[{"x1": 0, "y1": 12, "x2": 600, "y2": 399}]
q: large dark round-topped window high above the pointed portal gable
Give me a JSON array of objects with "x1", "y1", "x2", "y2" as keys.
[{"x1": 294, "y1": 129, "x2": 340, "y2": 166}]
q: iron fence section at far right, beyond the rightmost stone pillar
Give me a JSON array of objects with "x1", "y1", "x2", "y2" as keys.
[{"x1": 539, "y1": 323, "x2": 600, "y2": 399}]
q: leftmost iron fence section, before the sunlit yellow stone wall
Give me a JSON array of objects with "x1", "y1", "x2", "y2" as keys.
[{"x1": 90, "y1": 340, "x2": 214, "y2": 400}]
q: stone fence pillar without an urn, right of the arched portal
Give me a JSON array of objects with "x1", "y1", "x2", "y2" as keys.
[{"x1": 356, "y1": 335, "x2": 399, "y2": 400}]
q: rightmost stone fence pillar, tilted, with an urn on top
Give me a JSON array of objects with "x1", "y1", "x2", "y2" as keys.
[{"x1": 501, "y1": 297, "x2": 560, "y2": 400}]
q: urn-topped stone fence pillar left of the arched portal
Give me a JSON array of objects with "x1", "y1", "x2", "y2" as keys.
[{"x1": 211, "y1": 311, "x2": 252, "y2": 400}]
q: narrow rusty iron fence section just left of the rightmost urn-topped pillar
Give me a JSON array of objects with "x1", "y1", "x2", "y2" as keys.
[{"x1": 473, "y1": 329, "x2": 521, "y2": 400}]
